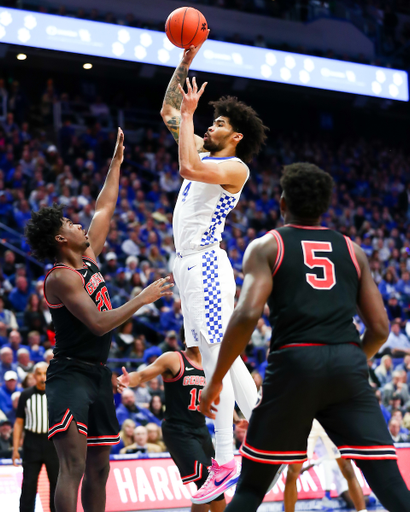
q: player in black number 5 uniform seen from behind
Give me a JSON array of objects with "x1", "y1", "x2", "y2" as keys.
[{"x1": 200, "y1": 163, "x2": 410, "y2": 512}]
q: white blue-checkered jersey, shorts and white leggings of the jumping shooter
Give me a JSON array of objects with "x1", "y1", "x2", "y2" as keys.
[{"x1": 173, "y1": 153, "x2": 257, "y2": 464}]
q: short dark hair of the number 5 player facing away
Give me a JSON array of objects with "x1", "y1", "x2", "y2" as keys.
[{"x1": 280, "y1": 163, "x2": 334, "y2": 219}]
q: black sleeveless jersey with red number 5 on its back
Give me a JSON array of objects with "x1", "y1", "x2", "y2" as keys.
[{"x1": 268, "y1": 224, "x2": 360, "y2": 350}]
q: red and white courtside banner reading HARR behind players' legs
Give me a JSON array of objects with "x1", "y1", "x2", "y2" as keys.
[{"x1": 0, "y1": 445, "x2": 410, "y2": 512}]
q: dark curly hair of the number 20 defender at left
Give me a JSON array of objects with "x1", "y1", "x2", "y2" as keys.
[{"x1": 25, "y1": 204, "x2": 64, "y2": 261}]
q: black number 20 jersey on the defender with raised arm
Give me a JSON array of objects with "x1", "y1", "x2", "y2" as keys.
[{"x1": 44, "y1": 256, "x2": 112, "y2": 363}]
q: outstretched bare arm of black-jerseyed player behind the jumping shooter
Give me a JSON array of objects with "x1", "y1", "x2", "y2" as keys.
[{"x1": 117, "y1": 352, "x2": 181, "y2": 392}]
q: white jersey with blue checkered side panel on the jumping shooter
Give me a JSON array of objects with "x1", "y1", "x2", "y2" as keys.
[{"x1": 172, "y1": 153, "x2": 249, "y2": 252}]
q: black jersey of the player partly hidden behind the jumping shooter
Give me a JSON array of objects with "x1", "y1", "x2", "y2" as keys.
[{"x1": 164, "y1": 352, "x2": 206, "y2": 427}]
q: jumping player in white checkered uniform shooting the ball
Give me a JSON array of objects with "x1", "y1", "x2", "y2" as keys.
[{"x1": 161, "y1": 41, "x2": 266, "y2": 504}]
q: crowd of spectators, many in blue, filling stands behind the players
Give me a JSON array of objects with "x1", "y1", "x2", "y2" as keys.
[{"x1": 0, "y1": 70, "x2": 410, "y2": 453}]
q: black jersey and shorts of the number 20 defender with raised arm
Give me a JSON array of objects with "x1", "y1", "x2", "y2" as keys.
[{"x1": 44, "y1": 256, "x2": 120, "y2": 446}]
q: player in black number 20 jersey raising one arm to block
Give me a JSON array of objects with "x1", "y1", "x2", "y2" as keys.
[{"x1": 26, "y1": 129, "x2": 172, "y2": 512}]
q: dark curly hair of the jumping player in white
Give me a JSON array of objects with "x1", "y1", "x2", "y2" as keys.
[{"x1": 209, "y1": 96, "x2": 269, "y2": 162}]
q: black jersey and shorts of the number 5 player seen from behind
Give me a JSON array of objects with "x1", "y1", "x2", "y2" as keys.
[{"x1": 241, "y1": 225, "x2": 397, "y2": 464}]
